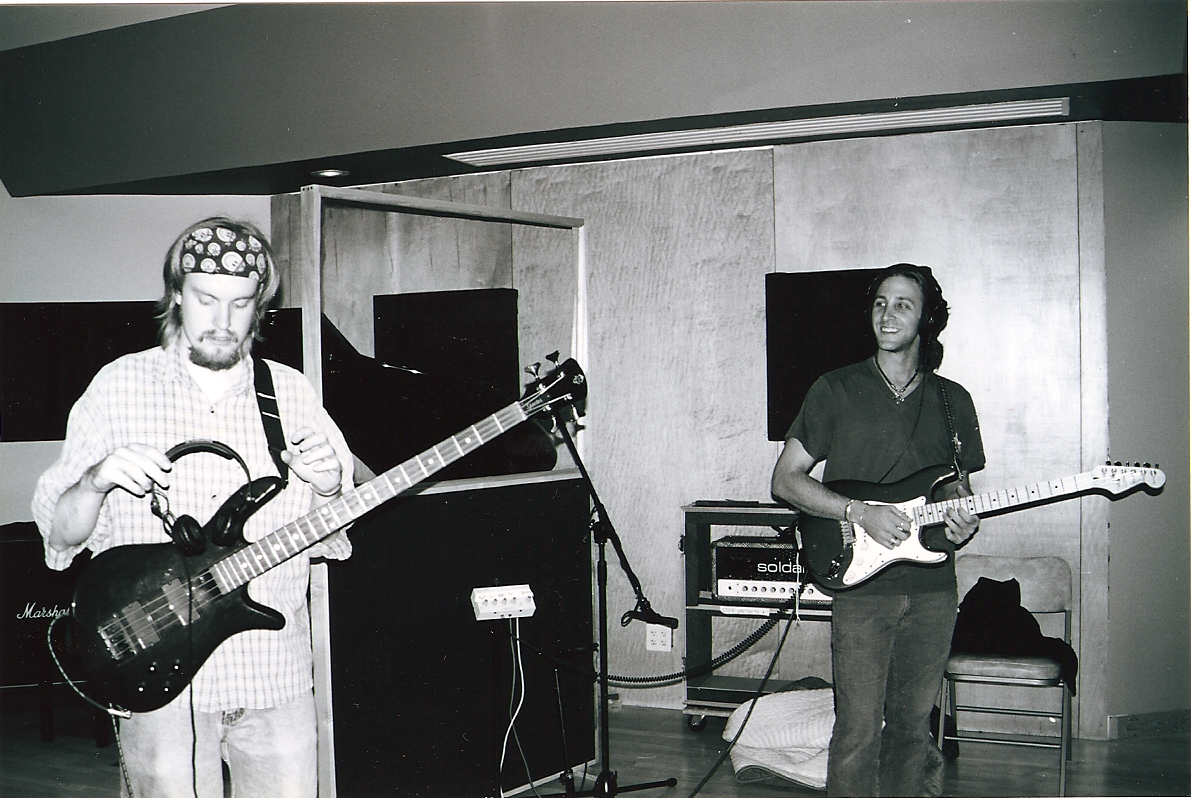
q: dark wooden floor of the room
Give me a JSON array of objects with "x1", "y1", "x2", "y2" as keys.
[{"x1": 0, "y1": 691, "x2": 1191, "y2": 798}]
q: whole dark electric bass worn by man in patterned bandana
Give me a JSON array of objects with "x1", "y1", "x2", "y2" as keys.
[{"x1": 55, "y1": 360, "x2": 587, "y2": 712}]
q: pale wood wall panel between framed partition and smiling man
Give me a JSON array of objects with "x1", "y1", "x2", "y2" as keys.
[{"x1": 513, "y1": 150, "x2": 775, "y2": 707}]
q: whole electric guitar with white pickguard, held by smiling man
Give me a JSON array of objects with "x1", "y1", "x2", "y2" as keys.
[{"x1": 798, "y1": 463, "x2": 1166, "y2": 590}]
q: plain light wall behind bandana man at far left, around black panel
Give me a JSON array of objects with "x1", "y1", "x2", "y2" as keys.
[{"x1": 0, "y1": 189, "x2": 269, "y2": 524}]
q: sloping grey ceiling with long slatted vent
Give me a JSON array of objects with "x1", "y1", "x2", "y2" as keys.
[{"x1": 0, "y1": 0, "x2": 1187, "y2": 197}]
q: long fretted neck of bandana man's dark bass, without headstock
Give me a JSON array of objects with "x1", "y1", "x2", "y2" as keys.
[{"x1": 210, "y1": 401, "x2": 529, "y2": 593}]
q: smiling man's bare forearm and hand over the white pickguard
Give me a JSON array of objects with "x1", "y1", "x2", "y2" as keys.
[{"x1": 771, "y1": 438, "x2": 909, "y2": 557}]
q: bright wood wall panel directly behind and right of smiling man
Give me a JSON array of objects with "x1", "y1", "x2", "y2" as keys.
[{"x1": 774, "y1": 125, "x2": 1103, "y2": 733}]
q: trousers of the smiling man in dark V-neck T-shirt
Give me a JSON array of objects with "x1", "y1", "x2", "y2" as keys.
[{"x1": 827, "y1": 591, "x2": 956, "y2": 796}]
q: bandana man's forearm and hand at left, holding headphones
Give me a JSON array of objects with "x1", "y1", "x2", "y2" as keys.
[{"x1": 49, "y1": 443, "x2": 173, "y2": 551}]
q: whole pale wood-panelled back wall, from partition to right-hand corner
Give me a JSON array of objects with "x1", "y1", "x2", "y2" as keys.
[{"x1": 321, "y1": 124, "x2": 1138, "y2": 736}]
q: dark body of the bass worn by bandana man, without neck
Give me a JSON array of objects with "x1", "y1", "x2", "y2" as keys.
[{"x1": 69, "y1": 542, "x2": 285, "y2": 712}]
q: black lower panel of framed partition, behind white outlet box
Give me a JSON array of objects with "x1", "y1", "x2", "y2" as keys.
[{"x1": 329, "y1": 480, "x2": 594, "y2": 798}]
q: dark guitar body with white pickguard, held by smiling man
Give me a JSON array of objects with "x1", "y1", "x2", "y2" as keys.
[{"x1": 798, "y1": 466, "x2": 955, "y2": 591}]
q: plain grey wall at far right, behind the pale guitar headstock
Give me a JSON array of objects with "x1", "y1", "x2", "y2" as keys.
[{"x1": 1104, "y1": 123, "x2": 1191, "y2": 716}]
